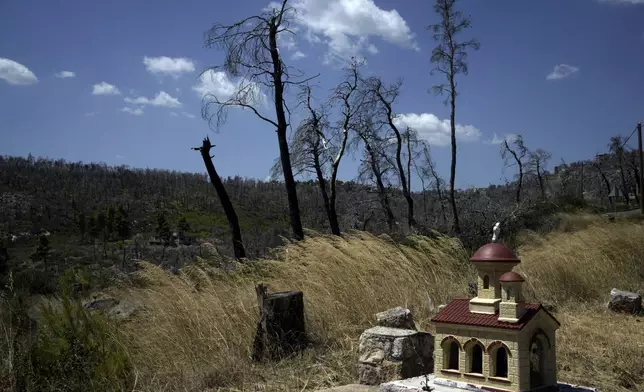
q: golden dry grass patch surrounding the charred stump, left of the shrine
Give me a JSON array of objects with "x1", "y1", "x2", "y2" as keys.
[{"x1": 118, "y1": 233, "x2": 471, "y2": 391}]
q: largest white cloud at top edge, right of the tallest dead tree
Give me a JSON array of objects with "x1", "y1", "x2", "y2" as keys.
[{"x1": 270, "y1": 0, "x2": 419, "y2": 63}]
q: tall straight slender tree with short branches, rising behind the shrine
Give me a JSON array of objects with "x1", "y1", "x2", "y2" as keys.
[{"x1": 429, "y1": 0, "x2": 480, "y2": 233}]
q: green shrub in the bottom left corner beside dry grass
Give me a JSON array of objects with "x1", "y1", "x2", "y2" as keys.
[{"x1": 28, "y1": 294, "x2": 131, "y2": 391}]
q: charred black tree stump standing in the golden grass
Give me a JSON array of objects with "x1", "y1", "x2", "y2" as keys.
[{"x1": 253, "y1": 283, "x2": 308, "y2": 362}]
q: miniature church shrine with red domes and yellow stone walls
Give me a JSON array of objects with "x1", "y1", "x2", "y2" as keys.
[{"x1": 431, "y1": 228, "x2": 560, "y2": 392}]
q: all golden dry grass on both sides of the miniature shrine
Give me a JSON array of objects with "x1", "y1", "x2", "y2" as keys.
[{"x1": 108, "y1": 217, "x2": 644, "y2": 391}]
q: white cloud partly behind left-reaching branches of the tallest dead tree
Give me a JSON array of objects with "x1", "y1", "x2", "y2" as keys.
[{"x1": 192, "y1": 70, "x2": 266, "y2": 104}]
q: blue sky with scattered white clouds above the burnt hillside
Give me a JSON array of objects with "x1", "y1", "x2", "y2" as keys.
[{"x1": 0, "y1": 0, "x2": 644, "y2": 187}]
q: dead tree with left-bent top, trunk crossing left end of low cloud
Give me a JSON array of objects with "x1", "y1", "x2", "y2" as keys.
[{"x1": 364, "y1": 76, "x2": 416, "y2": 229}]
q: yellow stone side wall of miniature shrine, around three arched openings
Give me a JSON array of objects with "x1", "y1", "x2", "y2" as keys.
[{"x1": 434, "y1": 325, "x2": 520, "y2": 392}]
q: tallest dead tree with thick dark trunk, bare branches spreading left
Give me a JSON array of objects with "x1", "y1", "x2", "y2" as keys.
[{"x1": 202, "y1": 0, "x2": 312, "y2": 240}]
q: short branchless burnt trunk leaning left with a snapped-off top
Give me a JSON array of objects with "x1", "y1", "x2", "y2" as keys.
[{"x1": 193, "y1": 137, "x2": 246, "y2": 260}]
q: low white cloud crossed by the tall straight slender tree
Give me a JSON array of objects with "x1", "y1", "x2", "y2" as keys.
[{"x1": 394, "y1": 113, "x2": 481, "y2": 146}]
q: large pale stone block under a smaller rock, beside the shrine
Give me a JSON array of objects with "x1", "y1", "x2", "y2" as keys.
[{"x1": 358, "y1": 326, "x2": 434, "y2": 385}]
